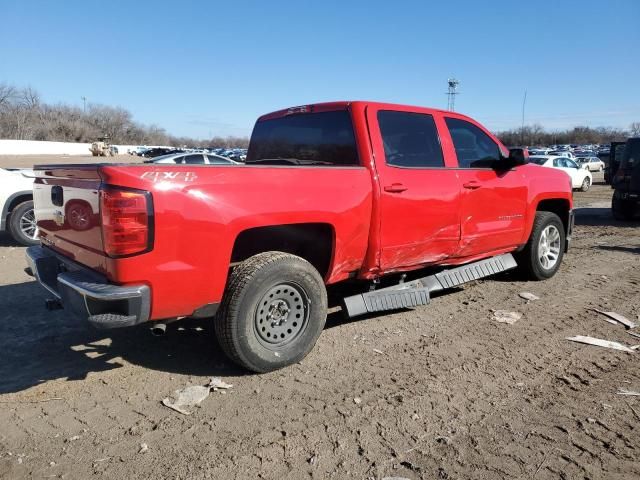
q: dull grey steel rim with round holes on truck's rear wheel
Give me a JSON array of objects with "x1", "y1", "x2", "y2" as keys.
[{"x1": 254, "y1": 283, "x2": 310, "y2": 349}]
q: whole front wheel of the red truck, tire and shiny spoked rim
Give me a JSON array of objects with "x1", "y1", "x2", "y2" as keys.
[{"x1": 516, "y1": 212, "x2": 565, "y2": 280}]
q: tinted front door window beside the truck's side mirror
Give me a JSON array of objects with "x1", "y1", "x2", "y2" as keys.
[{"x1": 445, "y1": 117, "x2": 500, "y2": 168}]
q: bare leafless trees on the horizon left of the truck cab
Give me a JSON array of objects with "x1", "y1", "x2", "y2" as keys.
[{"x1": 0, "y1": 83, "x2": 249, "y2": 148}]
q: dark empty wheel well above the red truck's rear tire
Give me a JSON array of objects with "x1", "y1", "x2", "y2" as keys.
[{"x1": 231, "y1": 223, "x2": 334, "y2": 277}]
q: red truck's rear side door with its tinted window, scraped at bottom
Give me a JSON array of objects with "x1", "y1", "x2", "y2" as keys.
[{"x1": 367, "y1": 106, "x2": 460, "y2": 271}]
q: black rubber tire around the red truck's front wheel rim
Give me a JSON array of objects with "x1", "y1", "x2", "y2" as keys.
[{"x1": 515, "y1": 212, "x2": 565, "y2": 281}]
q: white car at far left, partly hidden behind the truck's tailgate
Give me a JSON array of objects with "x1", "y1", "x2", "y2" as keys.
[{"x1": 0, "y1": 168, "x2": 40, "y2": 245}]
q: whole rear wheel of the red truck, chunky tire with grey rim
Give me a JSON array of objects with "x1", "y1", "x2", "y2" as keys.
[{"x1": 214, "y1": 252, "x2": 327, "y2": 373}]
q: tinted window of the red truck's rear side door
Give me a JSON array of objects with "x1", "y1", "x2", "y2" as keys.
[{"x1": 378, "y1": 110, "x2": 444, "y2": 168}]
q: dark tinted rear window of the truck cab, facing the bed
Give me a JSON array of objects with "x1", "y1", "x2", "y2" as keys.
[{"x1": 245, "y1": 110, "x2": 360, "y2": 167}]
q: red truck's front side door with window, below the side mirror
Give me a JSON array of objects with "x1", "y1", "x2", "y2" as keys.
[{"x1": 445, "y1": 116, "x2": 528, "y2": 257}]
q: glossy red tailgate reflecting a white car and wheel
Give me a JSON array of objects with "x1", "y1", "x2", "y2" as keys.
[{"x1": 33, "y1": 165, "x2": 105, "y2": 271}]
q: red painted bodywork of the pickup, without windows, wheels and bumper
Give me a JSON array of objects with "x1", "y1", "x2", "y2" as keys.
[{"x1": 35, "y1": 102, "x2": 572, "y2": 319}]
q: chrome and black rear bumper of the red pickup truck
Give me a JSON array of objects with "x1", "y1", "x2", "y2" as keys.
[{"x1": 26, "y1": 246, "x2": 151, "y2": 329}]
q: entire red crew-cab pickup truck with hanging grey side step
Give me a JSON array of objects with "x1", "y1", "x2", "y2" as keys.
[{"x1": 27, "y1": 102, "x2": 573, "y2": 372}]
